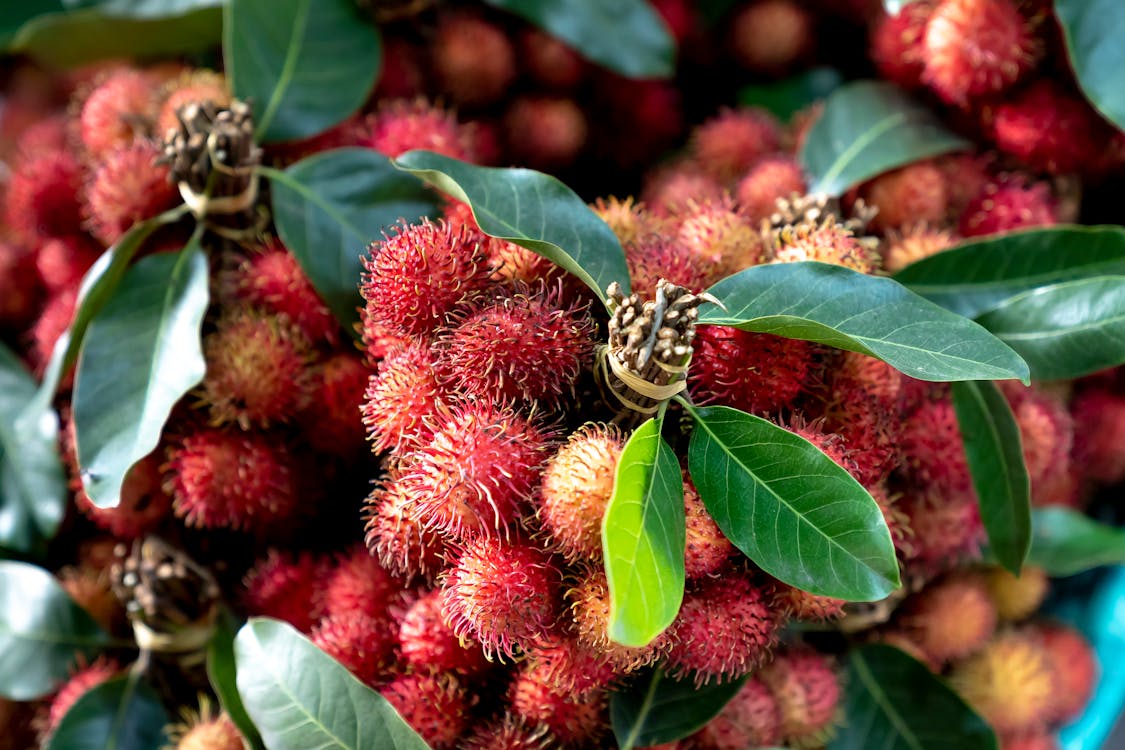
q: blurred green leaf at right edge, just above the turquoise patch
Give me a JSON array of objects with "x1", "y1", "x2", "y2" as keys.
[{"x1": 1027, "y1": 506, "x2": 1125, "y2": 577}]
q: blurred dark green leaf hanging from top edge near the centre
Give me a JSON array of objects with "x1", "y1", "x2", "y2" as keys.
[{"x1": 485, "y1": 0, "x2": 676, "y2": 78}]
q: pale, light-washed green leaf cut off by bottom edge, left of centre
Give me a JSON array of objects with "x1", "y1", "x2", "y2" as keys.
[{"x1": 234, "y1": 617, "x2": 428, "y2": 750}]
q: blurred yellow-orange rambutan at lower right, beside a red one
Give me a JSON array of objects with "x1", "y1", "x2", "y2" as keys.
[{"x1": 950, "y1": 631, "x2": 1056, "y2": 733}]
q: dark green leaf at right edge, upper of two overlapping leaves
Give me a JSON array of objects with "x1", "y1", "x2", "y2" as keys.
[{"x1": 894, "y1": 226, "x2": 1125, "y2": 318}]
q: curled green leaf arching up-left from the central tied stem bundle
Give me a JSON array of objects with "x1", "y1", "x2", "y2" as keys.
[{"x1": 392, "y1": 151, "x2": 629, "y2": 301}]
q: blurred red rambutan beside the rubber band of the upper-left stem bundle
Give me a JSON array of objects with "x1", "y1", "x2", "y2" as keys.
[{"x1": 84, "y1": 139, "x2": 180, "y2": 245}]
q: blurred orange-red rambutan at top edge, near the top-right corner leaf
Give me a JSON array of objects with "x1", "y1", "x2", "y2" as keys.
[{"x1": 923, "y1": 0, "x2": 1040, "y2": 106}]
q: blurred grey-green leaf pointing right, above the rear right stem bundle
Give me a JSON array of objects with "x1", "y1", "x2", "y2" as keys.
[{"x1": 799, "y1": 81, "x2": 972, "y2": 196}]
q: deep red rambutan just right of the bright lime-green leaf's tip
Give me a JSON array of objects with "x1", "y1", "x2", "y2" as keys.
[{"x1": 666, "y1": 575, "x2": 776, "y2": 685}]
